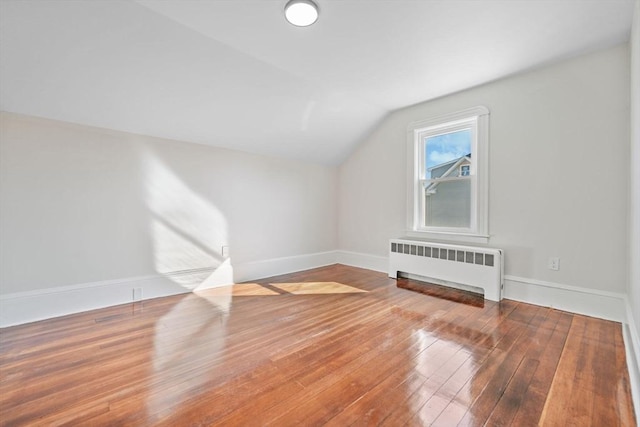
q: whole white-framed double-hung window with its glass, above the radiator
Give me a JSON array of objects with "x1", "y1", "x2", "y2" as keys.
[{"x1": 407, "y1": 107, "x2": 489, "y2": 242}]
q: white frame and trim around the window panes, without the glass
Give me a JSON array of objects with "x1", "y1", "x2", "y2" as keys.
[{"x1": 407, "y1": 106, "x2": 489, "y2": 243}]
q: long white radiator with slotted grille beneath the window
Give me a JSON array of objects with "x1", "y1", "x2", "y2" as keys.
[{"x1": 389, "y1": 239, "x2": 504, "y2": 301}]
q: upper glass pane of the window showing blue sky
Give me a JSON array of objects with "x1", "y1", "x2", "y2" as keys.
[{"x1": 425, "y1": 129, "x2": 471, "y2": 179}]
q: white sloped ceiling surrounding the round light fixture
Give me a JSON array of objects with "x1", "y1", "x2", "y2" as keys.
[{"x1": 0, "y1": 0, "x2": 634, "y2": 164}]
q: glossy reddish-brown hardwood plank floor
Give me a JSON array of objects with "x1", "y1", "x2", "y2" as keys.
[{"x1": 0, "y1": 265, "x2": 636, "y2": 426}]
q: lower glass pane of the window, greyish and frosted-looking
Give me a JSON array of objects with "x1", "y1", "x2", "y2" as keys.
[{"x1": 424, "y1": 179, "x2": 471, "y2": 228}]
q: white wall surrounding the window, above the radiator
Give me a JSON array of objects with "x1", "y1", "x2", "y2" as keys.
[{"x1": 338, "y1": 45, "x2": 629, "y2": 293}]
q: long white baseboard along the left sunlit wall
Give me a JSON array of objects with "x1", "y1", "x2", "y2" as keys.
[{"x1": 0, "y1": 251, "x2": 337, "y2": 328}]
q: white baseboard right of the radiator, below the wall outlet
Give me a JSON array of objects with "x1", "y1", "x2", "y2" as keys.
[{"x1": 502, "y1": 275, "x2": 626, "y2": 322}]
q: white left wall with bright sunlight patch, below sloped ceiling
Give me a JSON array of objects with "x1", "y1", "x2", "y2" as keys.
[{"x1": 0, "y1": 113, "x2": 337, "y2": 295}]
